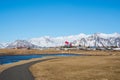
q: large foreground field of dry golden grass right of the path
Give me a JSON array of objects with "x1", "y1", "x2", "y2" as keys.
[{"x1": 30, "y1": 56, "x2": 120, "y2": 80}]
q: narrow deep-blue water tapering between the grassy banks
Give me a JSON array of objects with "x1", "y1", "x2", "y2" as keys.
[{"x1": 0, "y1": 54, "x2": 80, "y2": 65}]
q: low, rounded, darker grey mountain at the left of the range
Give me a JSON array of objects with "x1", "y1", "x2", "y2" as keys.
[{"x1": 6, "y1": 40, "x2": 38, "y2": 48}]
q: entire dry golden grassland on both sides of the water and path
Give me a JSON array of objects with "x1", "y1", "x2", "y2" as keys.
[{"x1": 0, "y1": 49, "x2": 120, "y2": 80}]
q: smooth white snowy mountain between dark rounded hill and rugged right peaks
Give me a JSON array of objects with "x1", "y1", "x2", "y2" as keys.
[{"x1": 29, "y1": 34, "x2": 88, "y2": 47}]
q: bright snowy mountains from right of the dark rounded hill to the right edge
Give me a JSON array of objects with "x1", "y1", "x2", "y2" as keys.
[{"x1": 29, "y1": 33, "x2": 120, "y2": 47}]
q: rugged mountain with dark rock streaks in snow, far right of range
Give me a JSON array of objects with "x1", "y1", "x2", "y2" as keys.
[{"x1": 73, "y1": 33, "x2": 120, "y2": 47}]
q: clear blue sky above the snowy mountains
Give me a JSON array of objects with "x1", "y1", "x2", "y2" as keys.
[{"x1": 0, "y1": 0, "x2": 120, "y2": 42}]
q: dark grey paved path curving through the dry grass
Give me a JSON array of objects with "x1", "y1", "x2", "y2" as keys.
[{"x1": 0, "y1": 58, "x2": 55, "y2": 80}]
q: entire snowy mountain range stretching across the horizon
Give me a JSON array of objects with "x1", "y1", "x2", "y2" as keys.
[{"x1": 0, "y1": 33, "x2": 120, "y2": 48}]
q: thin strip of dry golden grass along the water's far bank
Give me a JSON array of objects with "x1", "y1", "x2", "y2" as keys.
[{"x1": 0, "y1": 49, "x2": 120, "y2": 55}]
